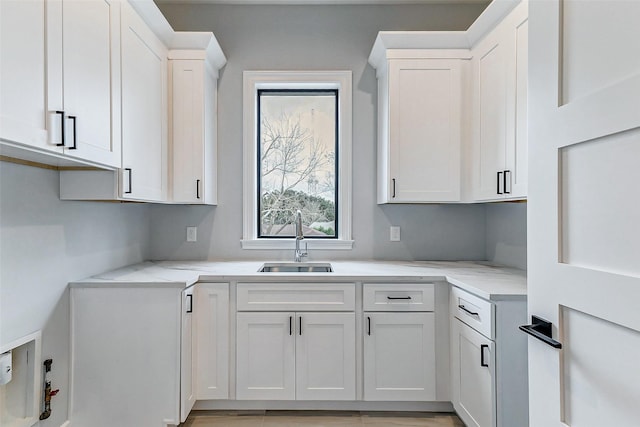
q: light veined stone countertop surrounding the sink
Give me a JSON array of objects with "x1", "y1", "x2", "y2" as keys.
[{"x1": 71, "y1": 261, "x2": 527, "y2": 301}]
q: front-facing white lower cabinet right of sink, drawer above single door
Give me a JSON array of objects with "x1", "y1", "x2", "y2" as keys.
[{"x1": 363, "y1": 283, "x2": 436, "y2": 401}]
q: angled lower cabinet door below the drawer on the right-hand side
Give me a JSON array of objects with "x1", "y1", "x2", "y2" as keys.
[{"x1": 452, "y1": 319, "x2": 496, "y2": 427}]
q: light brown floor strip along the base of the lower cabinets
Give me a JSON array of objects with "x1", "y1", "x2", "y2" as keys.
[{"x1": 182, "y1": 411, "x2": 464, "y2": 427}]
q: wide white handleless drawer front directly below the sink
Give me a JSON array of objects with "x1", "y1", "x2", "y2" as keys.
[{"x1": 237, "y1": 283, "x2": 356, "y2": 311}]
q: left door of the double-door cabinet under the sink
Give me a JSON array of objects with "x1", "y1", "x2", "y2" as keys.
[{"x1": 236, "y1": 312, "x2": 296, "y2": 400}]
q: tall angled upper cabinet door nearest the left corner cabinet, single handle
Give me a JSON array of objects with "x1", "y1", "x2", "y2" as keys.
[{"x1": 121, "y1": 0, "x2": 167, "y2": 201}]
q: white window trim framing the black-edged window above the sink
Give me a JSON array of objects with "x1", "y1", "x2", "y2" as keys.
[{"x1": 241, "y1": 71, "x2": 353, "y2": 250}]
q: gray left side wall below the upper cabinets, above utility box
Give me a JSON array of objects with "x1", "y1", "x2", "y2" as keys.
[{"x1": 0, "y1": 162, "x2": 150, "y2": 427}]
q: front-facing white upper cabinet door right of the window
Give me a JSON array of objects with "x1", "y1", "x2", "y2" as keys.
[{"x1": 388, "y1": 59, "x2": 462, "y2": 203}]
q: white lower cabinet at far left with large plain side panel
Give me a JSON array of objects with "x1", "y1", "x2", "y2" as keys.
[{"x1": 69, "y1": 283, "x2": 195, "y2": 427}]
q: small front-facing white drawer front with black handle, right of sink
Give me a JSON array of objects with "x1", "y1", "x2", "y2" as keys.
[{"x1": 363, "y1": 283, "x2": 435, "y2": 311}]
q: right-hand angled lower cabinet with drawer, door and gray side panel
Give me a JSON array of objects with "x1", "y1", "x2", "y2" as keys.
[{"x1": 450, "y1": 287, "x2": 529, "y2": 427}]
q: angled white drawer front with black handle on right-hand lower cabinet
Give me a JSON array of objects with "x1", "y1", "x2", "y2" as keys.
[{"x1": 450, "y1": 286, "x2": 495, "y2": 340}]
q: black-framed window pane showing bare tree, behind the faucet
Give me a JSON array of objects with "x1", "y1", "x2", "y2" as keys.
[{"x1": 257, "y1": 89, "x2": 339, "y2": 238}]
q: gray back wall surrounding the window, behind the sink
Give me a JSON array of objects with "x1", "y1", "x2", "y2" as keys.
[{"x1": 151, "y1": 3, "x2": 485, "y2": 260}]
